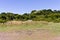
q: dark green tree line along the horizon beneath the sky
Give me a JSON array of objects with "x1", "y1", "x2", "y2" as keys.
[{"x1": 0, "y1": 9, "x2": 60, "y2": 23}]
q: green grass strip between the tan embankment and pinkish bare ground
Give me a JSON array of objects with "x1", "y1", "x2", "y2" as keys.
[{"x1": 0, "y1": 22, "x2": 60, "y2": 33}]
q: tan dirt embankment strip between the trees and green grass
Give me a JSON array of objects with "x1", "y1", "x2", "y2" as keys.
[{"x1": 5, "y1": 20, "x2": 48, "y2": 25}]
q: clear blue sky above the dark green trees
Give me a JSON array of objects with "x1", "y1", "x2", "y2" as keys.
[{"x1": 0, "y1": 0, "x2": 60, "y2": 14}]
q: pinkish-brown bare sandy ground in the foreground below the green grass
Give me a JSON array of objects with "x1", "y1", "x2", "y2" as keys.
[{"x1": 0, "y1": 29, "x2": 60, "y2": 40}]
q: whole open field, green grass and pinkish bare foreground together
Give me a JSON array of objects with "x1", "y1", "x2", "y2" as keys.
[{"x1": 0, "y1": 21, "x2": 60, "y2": 40}]
